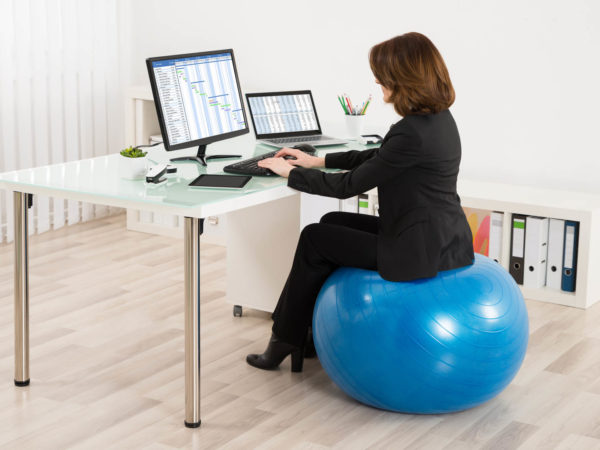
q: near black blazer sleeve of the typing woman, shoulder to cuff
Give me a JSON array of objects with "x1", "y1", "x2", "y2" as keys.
[{"x1": 288, "y1": 125, "x2": 422, "y2": 199}]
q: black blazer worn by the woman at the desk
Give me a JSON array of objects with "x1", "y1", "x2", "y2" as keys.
[{"x1": 288, "y1": 110, "x2": 474, "y2": 281}]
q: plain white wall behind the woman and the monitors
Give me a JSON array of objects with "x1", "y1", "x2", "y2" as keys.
[{"x1": 124, "y1": 0, "x2": 600, "y2": 192}]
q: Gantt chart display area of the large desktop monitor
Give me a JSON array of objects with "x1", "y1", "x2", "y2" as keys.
[{"x1": 152, "y1": 53, "x2": 246, "y2": 145}]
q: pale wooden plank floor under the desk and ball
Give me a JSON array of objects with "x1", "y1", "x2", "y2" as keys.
[{"x1": 0, "y1": 215, "x2": 600, "y2": 449}]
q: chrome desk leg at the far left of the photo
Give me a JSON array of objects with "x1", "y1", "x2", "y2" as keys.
[{"x1": 13, "y1": 192, "x2": 31, "y2": 386}]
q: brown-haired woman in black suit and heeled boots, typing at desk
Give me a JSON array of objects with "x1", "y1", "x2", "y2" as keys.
[{"x1": 246, "y1": 33, "x2": 474, "y2": 372}]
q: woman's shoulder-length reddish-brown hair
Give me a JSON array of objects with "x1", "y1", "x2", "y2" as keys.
[{"x1": 369, "y1": 33, "x2": 455, "y2": 116}]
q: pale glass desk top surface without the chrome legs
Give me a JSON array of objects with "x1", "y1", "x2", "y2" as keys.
[{"x1": 0, "y1": 134, "x2": 366, "y2": 217}]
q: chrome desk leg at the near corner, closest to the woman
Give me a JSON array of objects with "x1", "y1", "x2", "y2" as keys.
[{"x1": 183, "y1": 217, "x2": 204, "y2": 428}]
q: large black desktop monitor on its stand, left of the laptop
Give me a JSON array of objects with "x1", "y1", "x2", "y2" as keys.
[{"x1": 146, "y1": 49, "x2": 249, "y2": 165}]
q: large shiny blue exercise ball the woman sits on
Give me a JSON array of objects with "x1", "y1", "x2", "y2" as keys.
[{"x1": 313, "y1": 255, "x2": 529, "y2": 414}]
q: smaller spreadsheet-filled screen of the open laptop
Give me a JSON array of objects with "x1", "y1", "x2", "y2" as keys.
[{"x1": 246, "y1": 91, "x2": 321, "y2": 139}]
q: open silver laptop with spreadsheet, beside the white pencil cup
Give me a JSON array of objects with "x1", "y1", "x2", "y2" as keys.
[{"x1": 246, "y1": 91, "x2": 347, "y2": 147}]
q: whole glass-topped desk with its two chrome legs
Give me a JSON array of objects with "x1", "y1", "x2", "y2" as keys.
[{"x1": 0, "y1": 136, "x2": 362, "y2": 428}]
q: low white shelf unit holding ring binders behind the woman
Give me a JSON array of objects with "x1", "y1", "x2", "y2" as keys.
[{"x1": 369, "y1": 179, "x2": 600, "y2": 309}]
